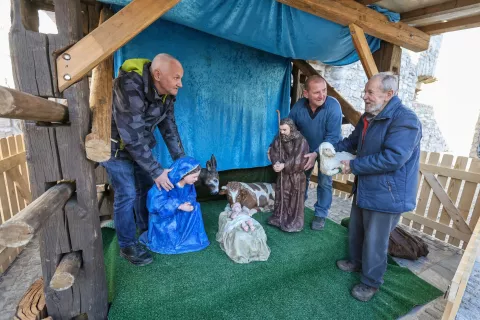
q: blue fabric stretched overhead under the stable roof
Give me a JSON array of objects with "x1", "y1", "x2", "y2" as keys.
[{"x1": 102, "y1": 0, "x2": 400, "y2": 65}]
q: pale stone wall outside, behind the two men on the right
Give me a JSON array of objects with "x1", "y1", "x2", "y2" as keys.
[{"x1": 311, "y1": 36, "x2": 448, "y2": 152}]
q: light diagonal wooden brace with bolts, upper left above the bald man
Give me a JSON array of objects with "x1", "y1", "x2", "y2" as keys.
[{"x1": 56, "y1": 0, "x2": 180, "y2": 91}]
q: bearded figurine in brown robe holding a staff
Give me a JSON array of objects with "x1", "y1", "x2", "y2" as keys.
[{"x1": 268, "y1": 118, "x2": 309, "y2": 232}]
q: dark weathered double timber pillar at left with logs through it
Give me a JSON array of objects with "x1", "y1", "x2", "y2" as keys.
[{"x1": 10, "y1": 0, "x2": 108, "y2": 319}]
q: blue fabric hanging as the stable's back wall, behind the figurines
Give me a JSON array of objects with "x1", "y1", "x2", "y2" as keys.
[{"x1": 114, "y1": 20, "x2": 291, "y2": 170}]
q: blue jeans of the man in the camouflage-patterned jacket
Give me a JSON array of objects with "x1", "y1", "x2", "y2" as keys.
[{"x1": 101, "y1": 158, "x2": 153, "y2": 248}]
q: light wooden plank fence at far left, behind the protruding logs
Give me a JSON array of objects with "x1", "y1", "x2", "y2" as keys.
[{"x1": 0, "y1": 135, "x2": 32, "y2": 273}]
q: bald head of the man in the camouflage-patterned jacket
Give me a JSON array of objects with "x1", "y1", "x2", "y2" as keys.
[{"x1": 150, "y1": 53, "x2": 183, "y2": 96}]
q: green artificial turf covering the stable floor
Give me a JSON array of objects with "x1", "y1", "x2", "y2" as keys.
[{"x1": 102, "y1": 201, "x2": 442, "y2": 320}]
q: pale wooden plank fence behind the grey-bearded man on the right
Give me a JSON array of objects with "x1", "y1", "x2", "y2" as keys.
[{"x1": 314, "y1": 151, "x2": 480, "y2": 248}]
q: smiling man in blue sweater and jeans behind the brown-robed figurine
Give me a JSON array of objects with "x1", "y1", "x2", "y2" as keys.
[{"x1": 289, "y1": 75, "x2": 342, "y2": 230}]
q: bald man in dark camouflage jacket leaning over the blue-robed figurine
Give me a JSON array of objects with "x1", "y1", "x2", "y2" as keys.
[{"x1": 102, "y1": 54, "x2": 185, "y2": 266}]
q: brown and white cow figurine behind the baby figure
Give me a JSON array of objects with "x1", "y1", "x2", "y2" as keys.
[{"x1": 219, "y1": 181, "x2": 275, "y2": 215}]
